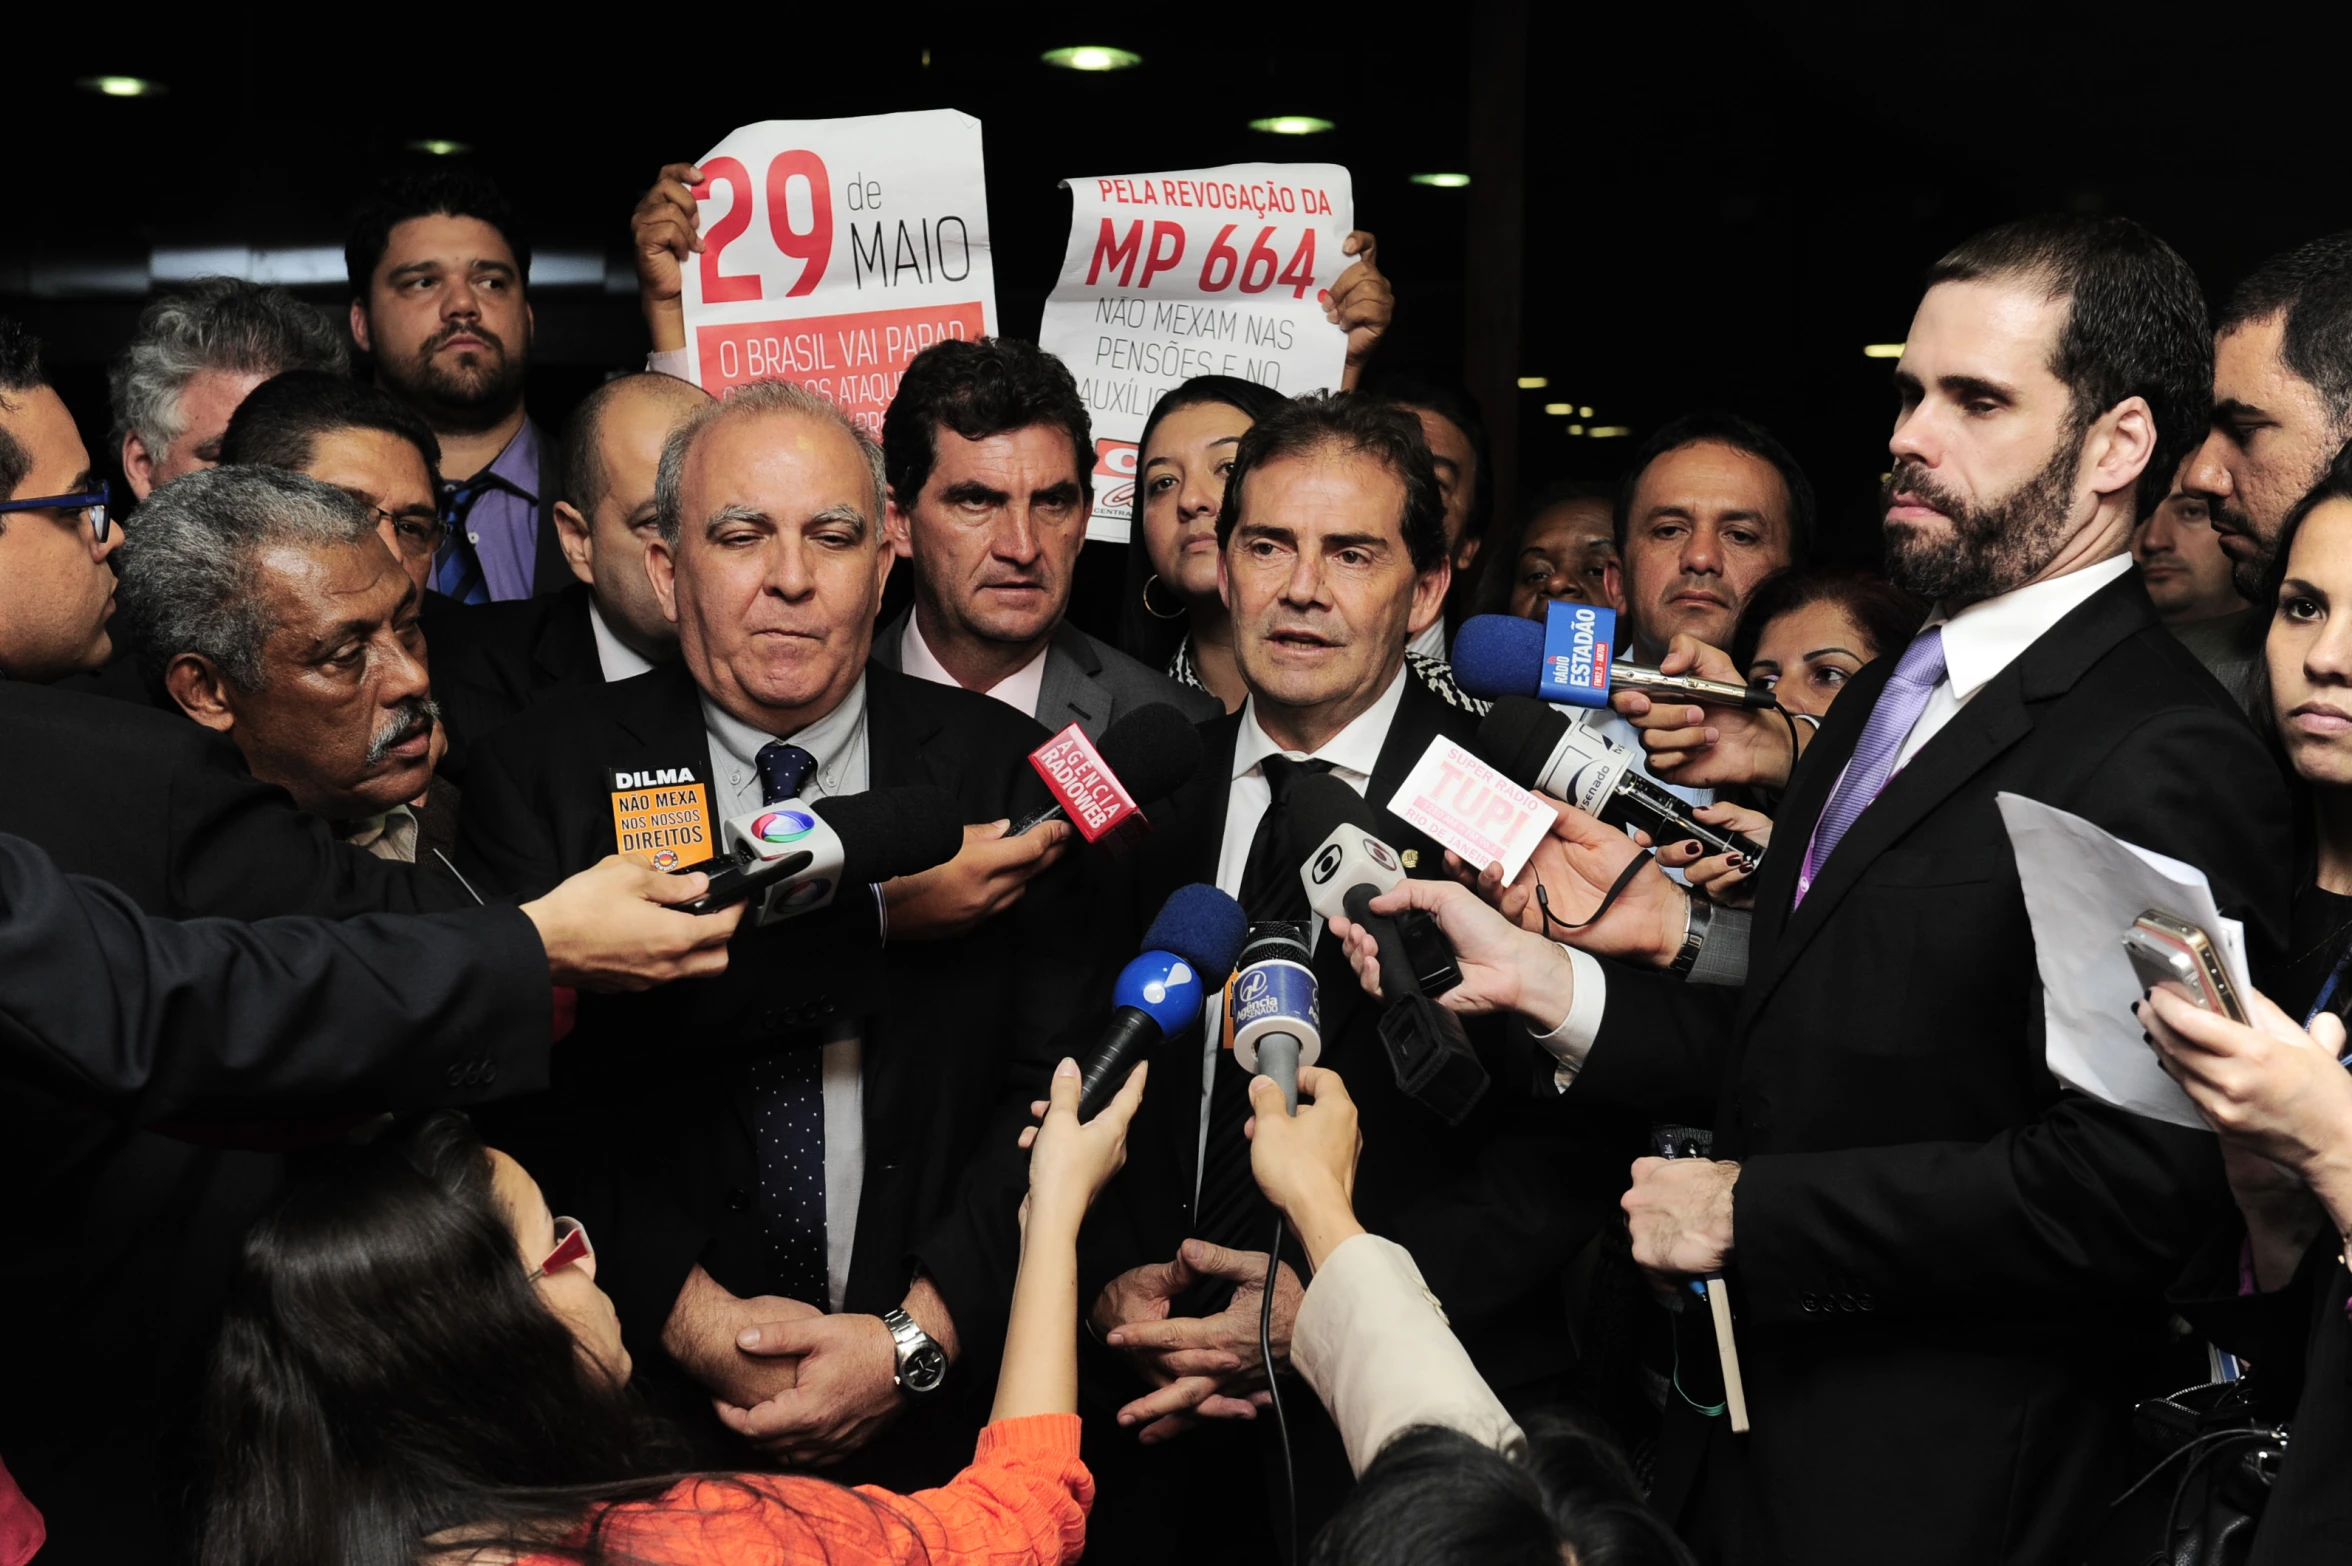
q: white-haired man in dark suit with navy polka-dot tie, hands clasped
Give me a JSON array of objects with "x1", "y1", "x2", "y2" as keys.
[{"x1": 461, "y1": 371, "x2": 1091, "y2": 1484}]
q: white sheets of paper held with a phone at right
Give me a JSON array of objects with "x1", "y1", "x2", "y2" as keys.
[{"x1": 1997, "y1": 795, "x2": 2253, "y2": 1131}]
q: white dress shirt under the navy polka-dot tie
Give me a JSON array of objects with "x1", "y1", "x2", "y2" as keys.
[{"x1": 703, "y1": 675, "x2": 868, "y2": 1312}]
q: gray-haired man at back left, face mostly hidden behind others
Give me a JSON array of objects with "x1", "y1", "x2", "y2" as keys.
[{"x1": 108, "y1": 277, "x2": 350, "y2": 501}]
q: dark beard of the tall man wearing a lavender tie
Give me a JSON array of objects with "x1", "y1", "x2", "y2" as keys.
[{"x1": 1879, "y1": 420, "x2": 2089, "y2": 611}]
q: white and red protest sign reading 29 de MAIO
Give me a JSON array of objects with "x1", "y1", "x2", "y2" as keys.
[{"x1": 684, "y1": 108, "x2": 997, "y2": 437}]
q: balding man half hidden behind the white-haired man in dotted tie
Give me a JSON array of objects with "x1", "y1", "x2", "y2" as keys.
[{"x1": 433, "y1": 374, "x2": 710, "y2": 783}]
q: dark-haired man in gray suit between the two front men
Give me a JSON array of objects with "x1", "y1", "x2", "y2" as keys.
[{"x1": 873, "y1": 336, "x2": 1218, "y2": 738}]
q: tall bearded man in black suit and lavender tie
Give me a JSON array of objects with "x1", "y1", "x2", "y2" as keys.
[{"x1": 1514, "y1": 219, "x2": 2291, "y2": 1564}]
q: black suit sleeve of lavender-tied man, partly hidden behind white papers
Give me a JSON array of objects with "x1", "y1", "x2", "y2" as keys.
[{"x1": 1733, "y1": 708, "x2": 2291, "y2": 1321}]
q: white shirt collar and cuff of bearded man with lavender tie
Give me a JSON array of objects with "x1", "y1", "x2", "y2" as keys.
[{"x1": 1534, "y1": 555, "x2": 2131, "y2": 1091}]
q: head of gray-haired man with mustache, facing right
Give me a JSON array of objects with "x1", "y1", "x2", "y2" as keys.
[{"x1": 115, "y1": 466, "x2": 440, "y2": 861}]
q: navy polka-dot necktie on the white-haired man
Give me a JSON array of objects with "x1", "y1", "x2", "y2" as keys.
[{"x1": 750, "y1": 743, "x2": 830, "y2": 1310}]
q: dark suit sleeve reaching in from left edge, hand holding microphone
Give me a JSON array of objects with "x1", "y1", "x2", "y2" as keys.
[{"x1": 0, "y1": 822, "x2": 550, "y2": 1122}]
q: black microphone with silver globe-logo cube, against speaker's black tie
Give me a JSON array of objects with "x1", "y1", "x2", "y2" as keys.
[{"x1": 1289, "y1": 774, "x2": 1486, "y2": 1126}]
